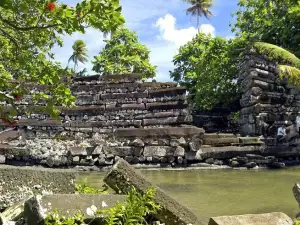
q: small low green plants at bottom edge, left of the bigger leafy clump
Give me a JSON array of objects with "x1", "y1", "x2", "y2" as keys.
[{"x1": 45, "y1": 210, "x2": 84, "y2": 225}]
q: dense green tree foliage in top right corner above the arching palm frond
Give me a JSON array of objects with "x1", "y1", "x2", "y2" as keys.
[{"x1": 232, "y1": 0, "x2": 300, "y2": 57}]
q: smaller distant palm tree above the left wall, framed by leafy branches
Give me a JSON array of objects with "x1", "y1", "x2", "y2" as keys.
[{"x1": 68, "y1": 40, "x2": 88, "y2": 71}]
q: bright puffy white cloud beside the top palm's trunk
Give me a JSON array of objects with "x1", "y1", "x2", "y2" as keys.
[{"x1": 155, "y1": 14, "x2": 215, "y2": 46}]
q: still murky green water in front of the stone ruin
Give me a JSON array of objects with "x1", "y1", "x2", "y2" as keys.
[{"x1": 80, "y1": 167, "x2": 300, "y2": 221}]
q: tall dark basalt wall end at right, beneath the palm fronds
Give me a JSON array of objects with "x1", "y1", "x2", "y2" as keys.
[{"x1": 239, "y1": 53, "x2": 300, "y2": 137}]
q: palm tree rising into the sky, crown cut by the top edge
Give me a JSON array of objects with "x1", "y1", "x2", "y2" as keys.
[{"x1": 182, "y1": 0, "x2": 213, "y2": 30}]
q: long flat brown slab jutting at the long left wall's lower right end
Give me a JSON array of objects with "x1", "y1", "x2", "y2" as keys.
[{"x1": 114, "y1": 126, "x2": 205, "y2": 137}]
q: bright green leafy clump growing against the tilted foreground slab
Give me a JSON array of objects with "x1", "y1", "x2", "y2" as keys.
[{"x1": 98, "y1": 188, "x2": 160, "y2": 225}]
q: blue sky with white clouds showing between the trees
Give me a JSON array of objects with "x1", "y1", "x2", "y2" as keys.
[{"x1": 53, "y1": 0, "x2": 238, "y2": 82}]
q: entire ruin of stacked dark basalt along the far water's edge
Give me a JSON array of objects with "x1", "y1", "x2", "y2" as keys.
[{"x1": 0, "y1": 53, "x2": 300, "y2": 169}]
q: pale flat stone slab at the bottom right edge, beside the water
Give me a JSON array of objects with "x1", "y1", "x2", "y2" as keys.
[{"x1": 208, "y1": 212, "x2": 294, "y2": 225}]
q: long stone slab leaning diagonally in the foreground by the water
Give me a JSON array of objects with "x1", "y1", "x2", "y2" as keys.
[{"x1": 104, "y1": 159, "x2": 204, "y2": 225}]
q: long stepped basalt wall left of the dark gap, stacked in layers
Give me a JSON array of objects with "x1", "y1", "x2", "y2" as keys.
[{"x1": 0, "y1": 75, "x2": 209, "y2": 167}]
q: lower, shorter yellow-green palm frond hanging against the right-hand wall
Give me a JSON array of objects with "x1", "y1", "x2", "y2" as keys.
[{"x1": 278, "y1": 65, "x2": 300, "y2": 88}]
